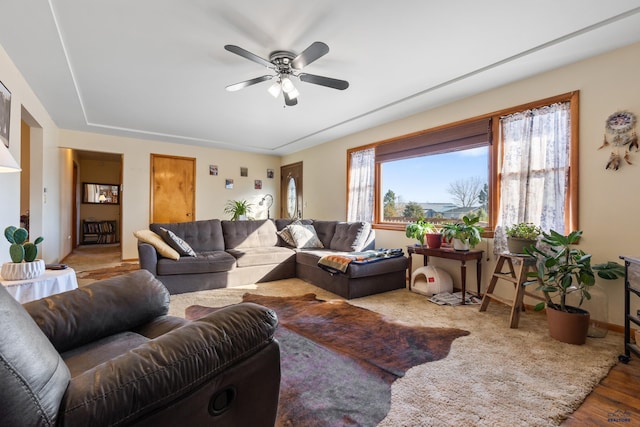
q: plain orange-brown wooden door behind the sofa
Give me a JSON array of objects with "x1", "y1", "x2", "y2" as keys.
[{"x1": 151, "y1": 154, "x2": 196, "y2": 222}]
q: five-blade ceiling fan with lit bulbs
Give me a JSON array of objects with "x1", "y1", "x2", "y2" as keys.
[{"x1": 224, "y1": 42, "x2": 349, "y2": 106}]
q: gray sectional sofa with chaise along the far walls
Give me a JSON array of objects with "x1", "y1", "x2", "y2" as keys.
[{"x1": 138, "y1": 219, "x2": 407, "y2": 299}]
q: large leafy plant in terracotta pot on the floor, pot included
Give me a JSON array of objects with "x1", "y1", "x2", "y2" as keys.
[{"x1": 525, "y1": 230, "x2": 624, "y2": 344}]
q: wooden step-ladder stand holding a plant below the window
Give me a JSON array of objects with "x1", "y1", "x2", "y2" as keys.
[{"x1": 480, "y1": 254, "x2": 545, "y2": 329}]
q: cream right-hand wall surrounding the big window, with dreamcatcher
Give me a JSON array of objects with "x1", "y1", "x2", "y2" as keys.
[{"x1": 283, "y1": 44, "x2": 640, "y2": 325}]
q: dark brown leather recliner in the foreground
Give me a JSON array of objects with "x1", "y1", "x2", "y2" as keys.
[{"x1": 0, "y1": 270, "x2": 280, "y2": 427}]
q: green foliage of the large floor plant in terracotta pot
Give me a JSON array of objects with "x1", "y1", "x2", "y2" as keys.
[{"x1": 525, "y1": 230, "x2": 624, "y2": 312}]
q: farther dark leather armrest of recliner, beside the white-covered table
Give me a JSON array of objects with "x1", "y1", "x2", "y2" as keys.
[{"x1": 23, "y1": 270, "x2": 170, "y2": 353}]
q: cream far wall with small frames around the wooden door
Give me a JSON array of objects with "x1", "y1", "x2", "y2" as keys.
[{"x1": 59, "y1": 130, "x2": 280, "y2": 259}]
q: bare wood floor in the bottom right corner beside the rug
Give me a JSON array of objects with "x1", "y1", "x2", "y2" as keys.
[{"x1": 562, "y1": 355, "x2": 640, "y2": 427}]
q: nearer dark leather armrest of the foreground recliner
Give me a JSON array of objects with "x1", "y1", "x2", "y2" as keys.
[{"x1": 59, "y1": 303, "x2": 278, "y2": 425}]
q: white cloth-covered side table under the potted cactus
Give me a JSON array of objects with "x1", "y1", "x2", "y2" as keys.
[{"x1": 0, "y1": 267, "x2": 78, "y2": 304}]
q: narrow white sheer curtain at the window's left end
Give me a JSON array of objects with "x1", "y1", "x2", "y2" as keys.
[{"x1": 347, "y1": 148, "x2": 376, "y2": 222}]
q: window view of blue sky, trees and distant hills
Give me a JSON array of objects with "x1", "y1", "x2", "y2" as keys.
[{"x1": 380, "y1": 146, "x2": 489, "y2": 225}]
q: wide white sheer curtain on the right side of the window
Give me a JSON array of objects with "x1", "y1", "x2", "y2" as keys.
[{"x1": 495, "y1": 102, "x2": 571, "y2": 253}]
